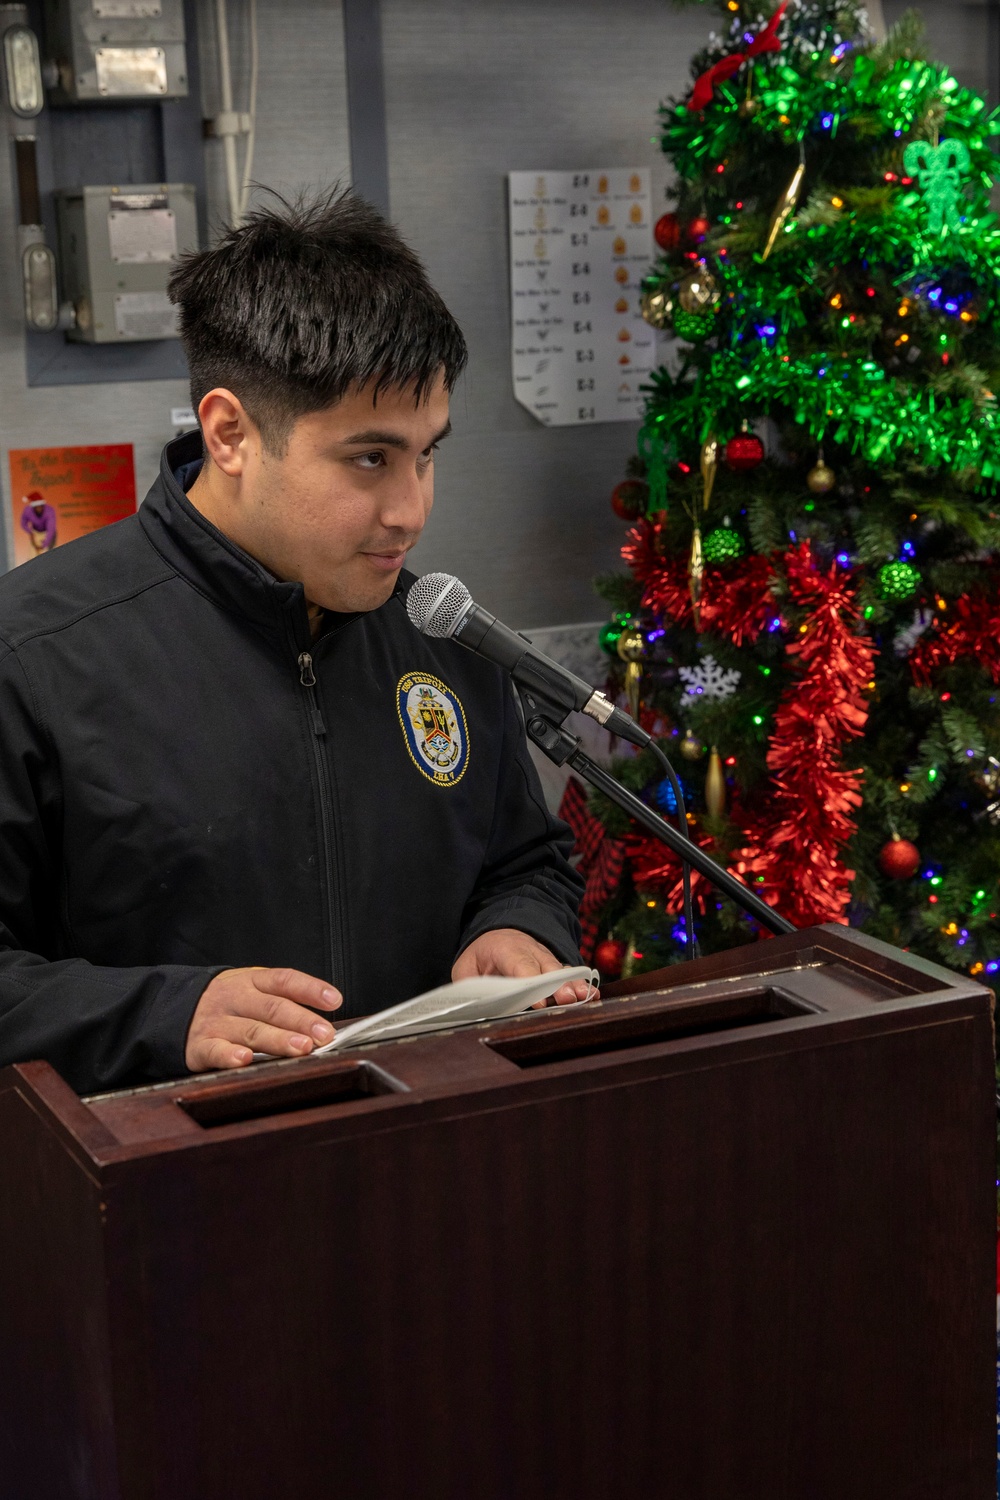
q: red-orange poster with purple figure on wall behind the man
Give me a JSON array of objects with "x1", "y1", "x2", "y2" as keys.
[{"x1": 9, "y1": 443, "x2": 135, "y2": 563}]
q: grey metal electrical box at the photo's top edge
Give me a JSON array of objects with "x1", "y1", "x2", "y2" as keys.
[{"x1": 45, "y1": 0, "x2": 187, "y2": 104}]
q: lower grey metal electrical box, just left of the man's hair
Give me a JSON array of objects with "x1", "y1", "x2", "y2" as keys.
[{"x1": 55, "y1": 183, "x2": 198, "y2": 344}]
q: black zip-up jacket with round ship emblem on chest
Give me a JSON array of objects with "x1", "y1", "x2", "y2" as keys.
[{"x1": 0, "y1": 435, "x2": 580, "y2": 1092}]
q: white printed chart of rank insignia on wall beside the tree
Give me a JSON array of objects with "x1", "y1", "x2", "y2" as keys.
[{"x1": 510, "y1": 167, "x2": 657, "y2": 428}]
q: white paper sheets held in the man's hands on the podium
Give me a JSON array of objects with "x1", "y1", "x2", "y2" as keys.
[{"x1": 253, "y1": 966, "x2": 600, "y2": 1059}]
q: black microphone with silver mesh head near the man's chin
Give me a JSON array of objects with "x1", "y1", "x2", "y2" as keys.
[{"x1": 406, "y1": 573, "x2": 652, "y2": 749}]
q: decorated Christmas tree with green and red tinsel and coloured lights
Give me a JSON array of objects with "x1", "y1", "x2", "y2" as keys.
[{"x1": 575, "y1": 0, "x2": 1000, "y2": 975}]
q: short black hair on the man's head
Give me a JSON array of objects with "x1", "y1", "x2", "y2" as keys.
[{"x1": 169, "y1": 189, "x2": 468, "y2": 453}]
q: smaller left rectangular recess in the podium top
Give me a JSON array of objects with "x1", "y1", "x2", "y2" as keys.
[{"x1": 174, "y1": 1062, "x2": 409, "y2": 1130}]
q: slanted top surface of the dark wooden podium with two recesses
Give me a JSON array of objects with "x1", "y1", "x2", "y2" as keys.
[{"x1": 15, "y1": 924, "x2": 993, "y2": 1173}]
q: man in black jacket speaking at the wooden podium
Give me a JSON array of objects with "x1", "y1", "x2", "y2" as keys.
[{"x1": 0, "y1": 195, "x2": 583, "y2": 1092}]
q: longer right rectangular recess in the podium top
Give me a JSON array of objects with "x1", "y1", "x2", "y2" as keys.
[{"x1": 487, "y1": 984, "x2": 822, "y2": 1068}]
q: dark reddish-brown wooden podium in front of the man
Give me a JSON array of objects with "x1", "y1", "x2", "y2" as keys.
[{"x1": 0, "y1": 927, "x2": 996, "y2": 1500}]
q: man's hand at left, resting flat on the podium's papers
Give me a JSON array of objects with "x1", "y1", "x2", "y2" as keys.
[{"x1": 184, "y1": 966, "x2": 344, "y2": 1073}]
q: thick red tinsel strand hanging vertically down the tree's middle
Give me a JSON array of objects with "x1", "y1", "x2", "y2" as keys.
[{"x1": 736, "y1": 542, "x2": 876, "y2": 927}]
